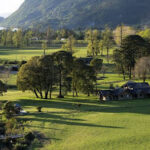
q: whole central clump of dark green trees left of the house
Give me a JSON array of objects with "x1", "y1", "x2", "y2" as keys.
[{"x1": 17, "y1": 51, "x2": 102, "y2": 99}]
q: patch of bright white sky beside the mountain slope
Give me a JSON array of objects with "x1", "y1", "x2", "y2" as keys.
[{"x1": 0, "y1": 0, "x2": 24, "y2": 18}]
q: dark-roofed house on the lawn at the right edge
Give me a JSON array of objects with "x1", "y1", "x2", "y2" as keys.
[{"x1": 99, "y1": 81, "x2": 150, "y2": 101}]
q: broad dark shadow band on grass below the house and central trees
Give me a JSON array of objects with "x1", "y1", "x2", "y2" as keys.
[{"x1": 16, "y1": 98, "x2": 150, "y2": 114}]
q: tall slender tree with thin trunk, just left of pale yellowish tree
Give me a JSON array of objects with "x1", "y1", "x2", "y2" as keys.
[{"x1": 102, "y1": 26, "x2": 114, "y2": 63}]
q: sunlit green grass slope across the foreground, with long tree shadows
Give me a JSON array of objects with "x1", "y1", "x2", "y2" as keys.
[{"x1": 1, "y1": 91, "x2": 150, "y2": 150}]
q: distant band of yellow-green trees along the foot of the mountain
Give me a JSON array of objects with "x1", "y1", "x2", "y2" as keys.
[{"x1": 0, "y1": 25, "x2": 139, "y2": 48}]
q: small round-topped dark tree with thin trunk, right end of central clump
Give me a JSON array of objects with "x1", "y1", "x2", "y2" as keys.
[{"x1": 90, "y1": 58, "x2": 103, "y2": 94}]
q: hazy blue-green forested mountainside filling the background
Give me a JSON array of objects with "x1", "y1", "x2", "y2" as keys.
[{"x1": 0, "y1": 0, "x2": 150, "y2": 28}]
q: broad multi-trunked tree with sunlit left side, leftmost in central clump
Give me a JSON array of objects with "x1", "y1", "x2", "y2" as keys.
[{"x1": 17, "y1": 55, "x2": 56, "y2": 99}]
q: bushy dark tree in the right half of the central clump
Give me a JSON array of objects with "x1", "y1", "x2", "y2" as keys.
[{"x1": 71, "y1": 59, "x2": 96, "y2": 96}]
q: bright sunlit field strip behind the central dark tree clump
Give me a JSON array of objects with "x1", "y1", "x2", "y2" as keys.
[{"x1": 0, "y1": 47, "x2": 113, "y2": 63}]
